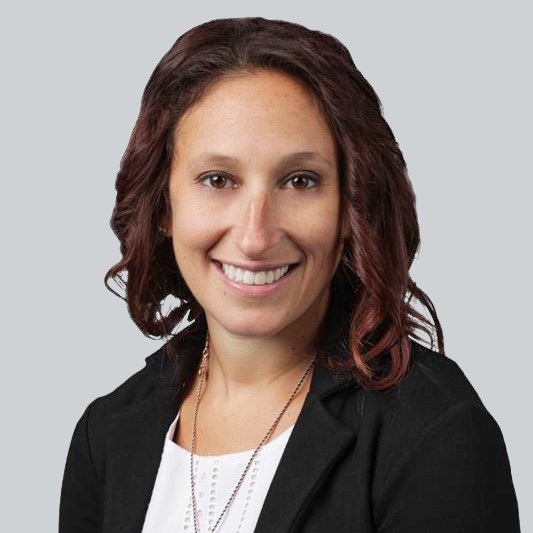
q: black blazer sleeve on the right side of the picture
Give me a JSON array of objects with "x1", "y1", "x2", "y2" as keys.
[{"x1": 375, "y1": 402, "x2": 520, "y2": 533}]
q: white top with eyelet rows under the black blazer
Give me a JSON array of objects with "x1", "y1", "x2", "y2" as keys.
[{"x1": 142, "y1": 412, "x2": 294, "y2": 533}]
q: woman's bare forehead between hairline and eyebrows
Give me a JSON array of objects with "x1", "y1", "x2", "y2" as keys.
[{"x1": 175, "y1": 71, "x2": 335, "y2": 165}]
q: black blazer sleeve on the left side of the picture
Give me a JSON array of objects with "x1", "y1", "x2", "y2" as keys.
[{"x1": 59, "y1": 402, "x2": 103, "y2": 533}]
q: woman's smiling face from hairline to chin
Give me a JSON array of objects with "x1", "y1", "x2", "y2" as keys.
[{"x1": 167, "y1": 71, "x2": 348, "y2": 337}]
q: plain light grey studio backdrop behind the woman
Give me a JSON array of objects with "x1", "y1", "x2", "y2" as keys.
[{"x1": 0, "y1": 1, "x2": 533, "y2": 532}]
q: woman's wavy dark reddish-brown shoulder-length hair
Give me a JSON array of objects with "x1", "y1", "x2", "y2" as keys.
[{"x1": 104, "y1": 17, "x2": 444, "y2": 390}]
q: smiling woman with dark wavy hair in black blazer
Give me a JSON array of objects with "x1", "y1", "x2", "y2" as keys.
[{"x1": 60, "y1": 18, "x2": 519, "y2": 533}]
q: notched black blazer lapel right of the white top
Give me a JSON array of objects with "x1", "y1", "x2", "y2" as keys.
[{"x1": 254, "y1": 365, "x2": 357, "y2": 533}]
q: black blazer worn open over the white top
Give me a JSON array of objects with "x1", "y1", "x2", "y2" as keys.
[{"x1": 59, "y1": 341, "x2": 520, "y2": 533}]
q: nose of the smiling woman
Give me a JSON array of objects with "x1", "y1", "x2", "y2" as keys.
[{"x1": 234, "y1": 190, "x2": 282, "y2": 259}]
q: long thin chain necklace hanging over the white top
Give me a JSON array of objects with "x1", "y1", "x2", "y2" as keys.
[{"x1": 190, "y1": 334, "x2": 317, "y2": 533}]
